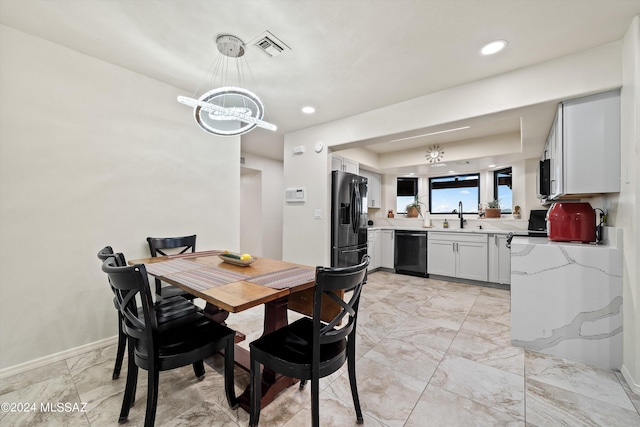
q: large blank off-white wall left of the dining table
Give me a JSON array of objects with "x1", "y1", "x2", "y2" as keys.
[{"x1": 0, "y1": 26, "x2": 240, "y2": 368}]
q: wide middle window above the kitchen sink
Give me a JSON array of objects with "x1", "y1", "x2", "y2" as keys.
[{"x1": 429, "y1": 173, "x2": 480, "y2": 214}]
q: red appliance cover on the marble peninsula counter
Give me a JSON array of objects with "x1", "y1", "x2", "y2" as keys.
[{"x1": 547, "y1": 203, "x2": 596, "y2": 243}]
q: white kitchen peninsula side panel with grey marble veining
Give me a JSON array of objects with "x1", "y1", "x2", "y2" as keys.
[{"x1": 511, "y1": 231, "x2": 622, "y2": 369}]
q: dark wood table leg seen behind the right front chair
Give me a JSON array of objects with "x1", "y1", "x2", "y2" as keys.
[{"x1": 239, "y1": 298, "x2": 298, "y2": 411}]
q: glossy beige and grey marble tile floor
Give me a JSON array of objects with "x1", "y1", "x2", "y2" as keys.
[{"x1": 0, "y1": 272, "x2": 640, "y2": 427}]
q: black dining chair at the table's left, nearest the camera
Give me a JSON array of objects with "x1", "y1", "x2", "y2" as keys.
[{"x1": 102, "y1": 254, "x2": 237, "y2": 427}]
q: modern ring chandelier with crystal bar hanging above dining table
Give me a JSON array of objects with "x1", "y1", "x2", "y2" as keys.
[{"x1": 178, "y1": 35, "x2": 277, "y2": 136}]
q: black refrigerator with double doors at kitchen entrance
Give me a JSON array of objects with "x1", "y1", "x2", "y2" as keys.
[{"x1": 331, "y1": 171, "x2": 367, "y2": 267}]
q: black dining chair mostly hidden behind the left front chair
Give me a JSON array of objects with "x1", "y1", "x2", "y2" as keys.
[{"x1": 98, "y1": 246, "x2": 201, "y2": 380}]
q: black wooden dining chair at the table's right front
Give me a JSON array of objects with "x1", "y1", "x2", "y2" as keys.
[{"x1": 249, "y1": 255, "x2": 370, "y2": 427}]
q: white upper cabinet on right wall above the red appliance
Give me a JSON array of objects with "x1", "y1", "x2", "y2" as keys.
[{"x1": 543, "y1": 90, "x2": 620, "y2": 200}]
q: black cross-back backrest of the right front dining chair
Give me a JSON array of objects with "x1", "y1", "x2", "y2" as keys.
[{"x1": 313, "y1": 255, "x2": 371, "y2": 351}]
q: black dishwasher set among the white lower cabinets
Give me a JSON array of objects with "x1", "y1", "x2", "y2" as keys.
[{"x1": 394, "y1": 230, "x2": 428, "y2": 277}]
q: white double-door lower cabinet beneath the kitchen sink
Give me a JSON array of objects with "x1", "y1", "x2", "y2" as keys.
[{"x1": 427, "y1": 232, "x2": 488, "y2": 282}]
